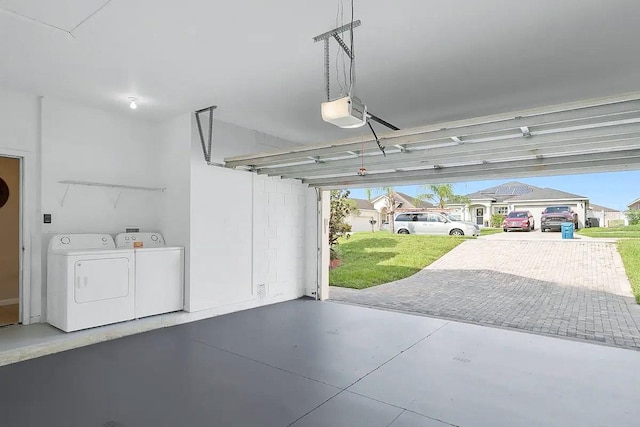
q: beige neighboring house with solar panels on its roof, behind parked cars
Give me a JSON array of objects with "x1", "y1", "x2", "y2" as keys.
[{"x1": 448, "y1": 182, "x2": 589, "y2": 228}]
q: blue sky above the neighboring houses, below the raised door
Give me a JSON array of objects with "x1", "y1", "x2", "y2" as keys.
[{"x1": 350, "y1": 171, "x2": 640, "y2": 211}]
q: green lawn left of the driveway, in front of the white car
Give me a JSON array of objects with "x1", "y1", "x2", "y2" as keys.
[{"x1": 329, "y1": 231, "x2": 465, "y2": 289}]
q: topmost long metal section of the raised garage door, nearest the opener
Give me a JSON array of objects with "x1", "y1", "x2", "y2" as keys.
[{"x1": 225, "y1": 93, "x2": 640, "y2": 168}]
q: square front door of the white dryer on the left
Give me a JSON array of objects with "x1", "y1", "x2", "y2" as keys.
[{"x1": 74, "y1": 258, "x2": 129, "y2": 304}]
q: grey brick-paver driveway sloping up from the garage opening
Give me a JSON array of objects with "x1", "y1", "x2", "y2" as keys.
[{"x1": 330, "y1": 232, "x2": 640, "y2": 349}]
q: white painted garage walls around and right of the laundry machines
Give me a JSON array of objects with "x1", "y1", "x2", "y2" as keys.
[{"x1": 0, "y1": 86, "x2": 318, "y2": 328}]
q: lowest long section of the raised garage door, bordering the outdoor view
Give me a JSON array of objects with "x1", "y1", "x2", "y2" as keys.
[{"x1": 302, "y1": 148, "x2": 640, "y2": 189}]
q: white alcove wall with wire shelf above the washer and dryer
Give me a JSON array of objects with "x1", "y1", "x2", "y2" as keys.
[{"x1": 42, "y1": 98, "x2": 163, "y2": 235}]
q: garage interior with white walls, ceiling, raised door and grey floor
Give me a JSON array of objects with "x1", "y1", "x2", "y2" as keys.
[{"x1": 0, "y1": 0, "x2": 640, "y2": 427}]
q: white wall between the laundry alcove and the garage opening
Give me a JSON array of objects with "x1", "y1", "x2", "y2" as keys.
[{"x1": 185, "y1": 120, "x2": 316, "y2": 313}]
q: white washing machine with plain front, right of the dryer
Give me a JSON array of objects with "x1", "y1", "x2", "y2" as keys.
[{"x1": 116, "y1": 233, "x2": 184, "y2": 318}]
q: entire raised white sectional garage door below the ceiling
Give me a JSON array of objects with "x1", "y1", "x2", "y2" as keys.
[{"x1": 225, "y1": 93, "x2": 640, "y2": 189}]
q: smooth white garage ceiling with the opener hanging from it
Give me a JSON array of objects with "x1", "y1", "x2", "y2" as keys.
[{"x1": 0, "y1": 0, "x2": 640, "y2": 143}]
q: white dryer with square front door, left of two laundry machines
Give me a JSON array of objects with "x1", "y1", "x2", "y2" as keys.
[{"x1": 47, "y1": 234, "x2": 135, "y2": 332}]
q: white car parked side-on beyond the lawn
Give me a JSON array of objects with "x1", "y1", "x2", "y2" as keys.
[{"x1": 393, "y1": 212, "x2": 480, "y2": 236}]
